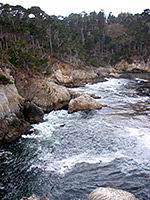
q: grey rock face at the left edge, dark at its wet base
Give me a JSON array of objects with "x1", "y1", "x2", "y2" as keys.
[{"x1": 0, "y1": 84, "x2": 29, "y2": 143}]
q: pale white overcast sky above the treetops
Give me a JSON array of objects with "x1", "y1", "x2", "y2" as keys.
[{"x1": 0, "y1": 0, "x2": 150, "y2": 16}]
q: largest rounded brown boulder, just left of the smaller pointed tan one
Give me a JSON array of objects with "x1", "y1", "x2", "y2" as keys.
[{"x1": 16, "y1": 74, "x2": 71, "y2": 112}]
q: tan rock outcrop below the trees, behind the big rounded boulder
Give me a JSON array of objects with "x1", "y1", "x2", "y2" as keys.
[{"x1": 51, "y1": 64, "x2": 119, "y2": 87}]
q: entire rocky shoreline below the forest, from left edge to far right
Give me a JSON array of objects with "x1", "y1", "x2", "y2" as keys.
[{"x1": 0, "y1": 58, "x2": 150, "y2": 144}]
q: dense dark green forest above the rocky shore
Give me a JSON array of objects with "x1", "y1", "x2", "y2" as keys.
[{"x1": 0, "y1": 3, "x2": 150, "y2": 73}]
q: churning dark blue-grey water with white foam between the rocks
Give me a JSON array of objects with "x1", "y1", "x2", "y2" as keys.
[{"x1": 0, "y1": 75, "x2": 150, "y2": 200}]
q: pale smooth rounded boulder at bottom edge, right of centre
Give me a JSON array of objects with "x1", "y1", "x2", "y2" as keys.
[{"x1": 87, "y1": 187, "x2": 138, "y2": 200}]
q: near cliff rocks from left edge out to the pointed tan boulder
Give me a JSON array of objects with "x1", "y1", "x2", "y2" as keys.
[{"x1": 0, "y1": 66, "x2": 105, "y2": 144}]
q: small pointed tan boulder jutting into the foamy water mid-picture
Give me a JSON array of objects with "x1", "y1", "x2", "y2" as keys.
[{"x1": 68, "y1": 94, "x2": 103, "y2": 113}]
